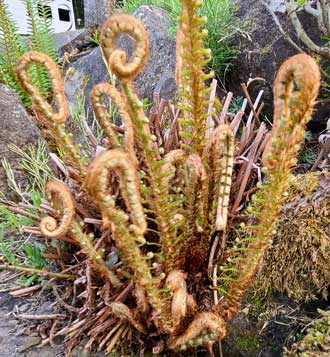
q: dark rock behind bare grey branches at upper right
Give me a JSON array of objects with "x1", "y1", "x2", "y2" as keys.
[{"x1": 227, "y1": 0, "x2": 330, "y2": 131}]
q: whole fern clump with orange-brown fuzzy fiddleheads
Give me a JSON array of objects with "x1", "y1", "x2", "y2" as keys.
[{"x1": 6, "y1": 0, "x2": 320, "y2": 353}]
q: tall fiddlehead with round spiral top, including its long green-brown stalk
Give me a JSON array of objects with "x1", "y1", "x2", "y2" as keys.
[{"x1": 101, "y1": 15, "x2": 180, "y2": 271}]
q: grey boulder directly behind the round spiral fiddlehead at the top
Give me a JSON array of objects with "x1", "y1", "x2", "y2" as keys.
[{"x1": 65, "y1": 6, "x2": 175, "y2": 119}]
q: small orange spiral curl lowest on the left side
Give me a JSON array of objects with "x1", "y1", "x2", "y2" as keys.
[{"x1": 40, "y1": 180, "x2": 75, "y2": 238}]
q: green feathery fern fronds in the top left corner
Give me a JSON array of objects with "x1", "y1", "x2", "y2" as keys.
[{"x1": 0, "y1": 0, "x2": 58, "y2": 107}]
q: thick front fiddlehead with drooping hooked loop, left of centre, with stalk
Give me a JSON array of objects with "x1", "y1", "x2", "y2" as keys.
[{"x1": 86, "y1": 149, "x2": 172, "y2": 331}]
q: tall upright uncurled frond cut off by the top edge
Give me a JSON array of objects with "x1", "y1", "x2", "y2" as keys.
[{"x1": 177, "y1": 0, "x2": 213, "y2": 155}]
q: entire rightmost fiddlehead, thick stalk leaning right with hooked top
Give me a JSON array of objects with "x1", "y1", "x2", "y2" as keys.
[{"x1": 216, "y1": 54, "x2": 320, "y2": 319}]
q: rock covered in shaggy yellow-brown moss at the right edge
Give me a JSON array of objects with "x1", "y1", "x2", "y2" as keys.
[{"x1": 255, "y1": 172, "x2": 330, "y2": 302}]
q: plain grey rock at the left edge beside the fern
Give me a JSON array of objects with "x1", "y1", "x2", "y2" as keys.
[{"x1": 0, "y1": 84, "x2": 40, "y2": 199}]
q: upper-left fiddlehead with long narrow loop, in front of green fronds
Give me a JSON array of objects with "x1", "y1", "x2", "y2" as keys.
[{"x1": 16, "y1": 51, "x2": 86, "y2": 179}]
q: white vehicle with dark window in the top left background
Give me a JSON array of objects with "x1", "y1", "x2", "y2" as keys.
[{"x1": 4, "y1": 0, "x2": 76, "y2": 35}]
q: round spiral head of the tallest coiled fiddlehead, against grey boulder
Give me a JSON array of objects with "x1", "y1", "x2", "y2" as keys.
[{"x1": 100, "y1": 14, "x2": 149, "y2": 81}]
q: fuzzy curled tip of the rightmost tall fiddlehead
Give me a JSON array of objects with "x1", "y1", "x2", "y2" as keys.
[{"x1": 263, "y1": 54, "x2": 320, "y2": 169}]
